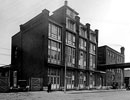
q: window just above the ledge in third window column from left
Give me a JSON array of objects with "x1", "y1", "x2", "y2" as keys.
[{"x1": 79, "y1": 51, "x2": 86, "y2": 69}]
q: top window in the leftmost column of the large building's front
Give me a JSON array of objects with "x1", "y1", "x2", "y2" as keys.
[{"x1": 49, "y1": 23, "x2": 61, "y2": 41}]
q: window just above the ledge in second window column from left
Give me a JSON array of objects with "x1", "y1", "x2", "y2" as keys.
[{"x1": 66, "y1": 46, "x2": 75, "y2": 67}]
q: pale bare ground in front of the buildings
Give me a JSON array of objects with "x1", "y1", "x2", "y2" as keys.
[{"x1": 0, "y1": 90, "x2": 130, "y2": 100}]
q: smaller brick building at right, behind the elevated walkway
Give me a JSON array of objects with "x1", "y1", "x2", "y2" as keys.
[{"x1": 98, "y1": 45, "x2": 125, "y2": 88}]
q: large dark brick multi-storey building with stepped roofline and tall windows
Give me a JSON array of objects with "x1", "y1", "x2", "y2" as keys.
[{"x1": 11, "y1": 1, "x2": 103, "y2": 90}]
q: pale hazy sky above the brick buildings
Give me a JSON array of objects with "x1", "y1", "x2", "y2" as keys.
[{"x1": 0, "y1": 0, "x2": 130, "y2": 66}]
